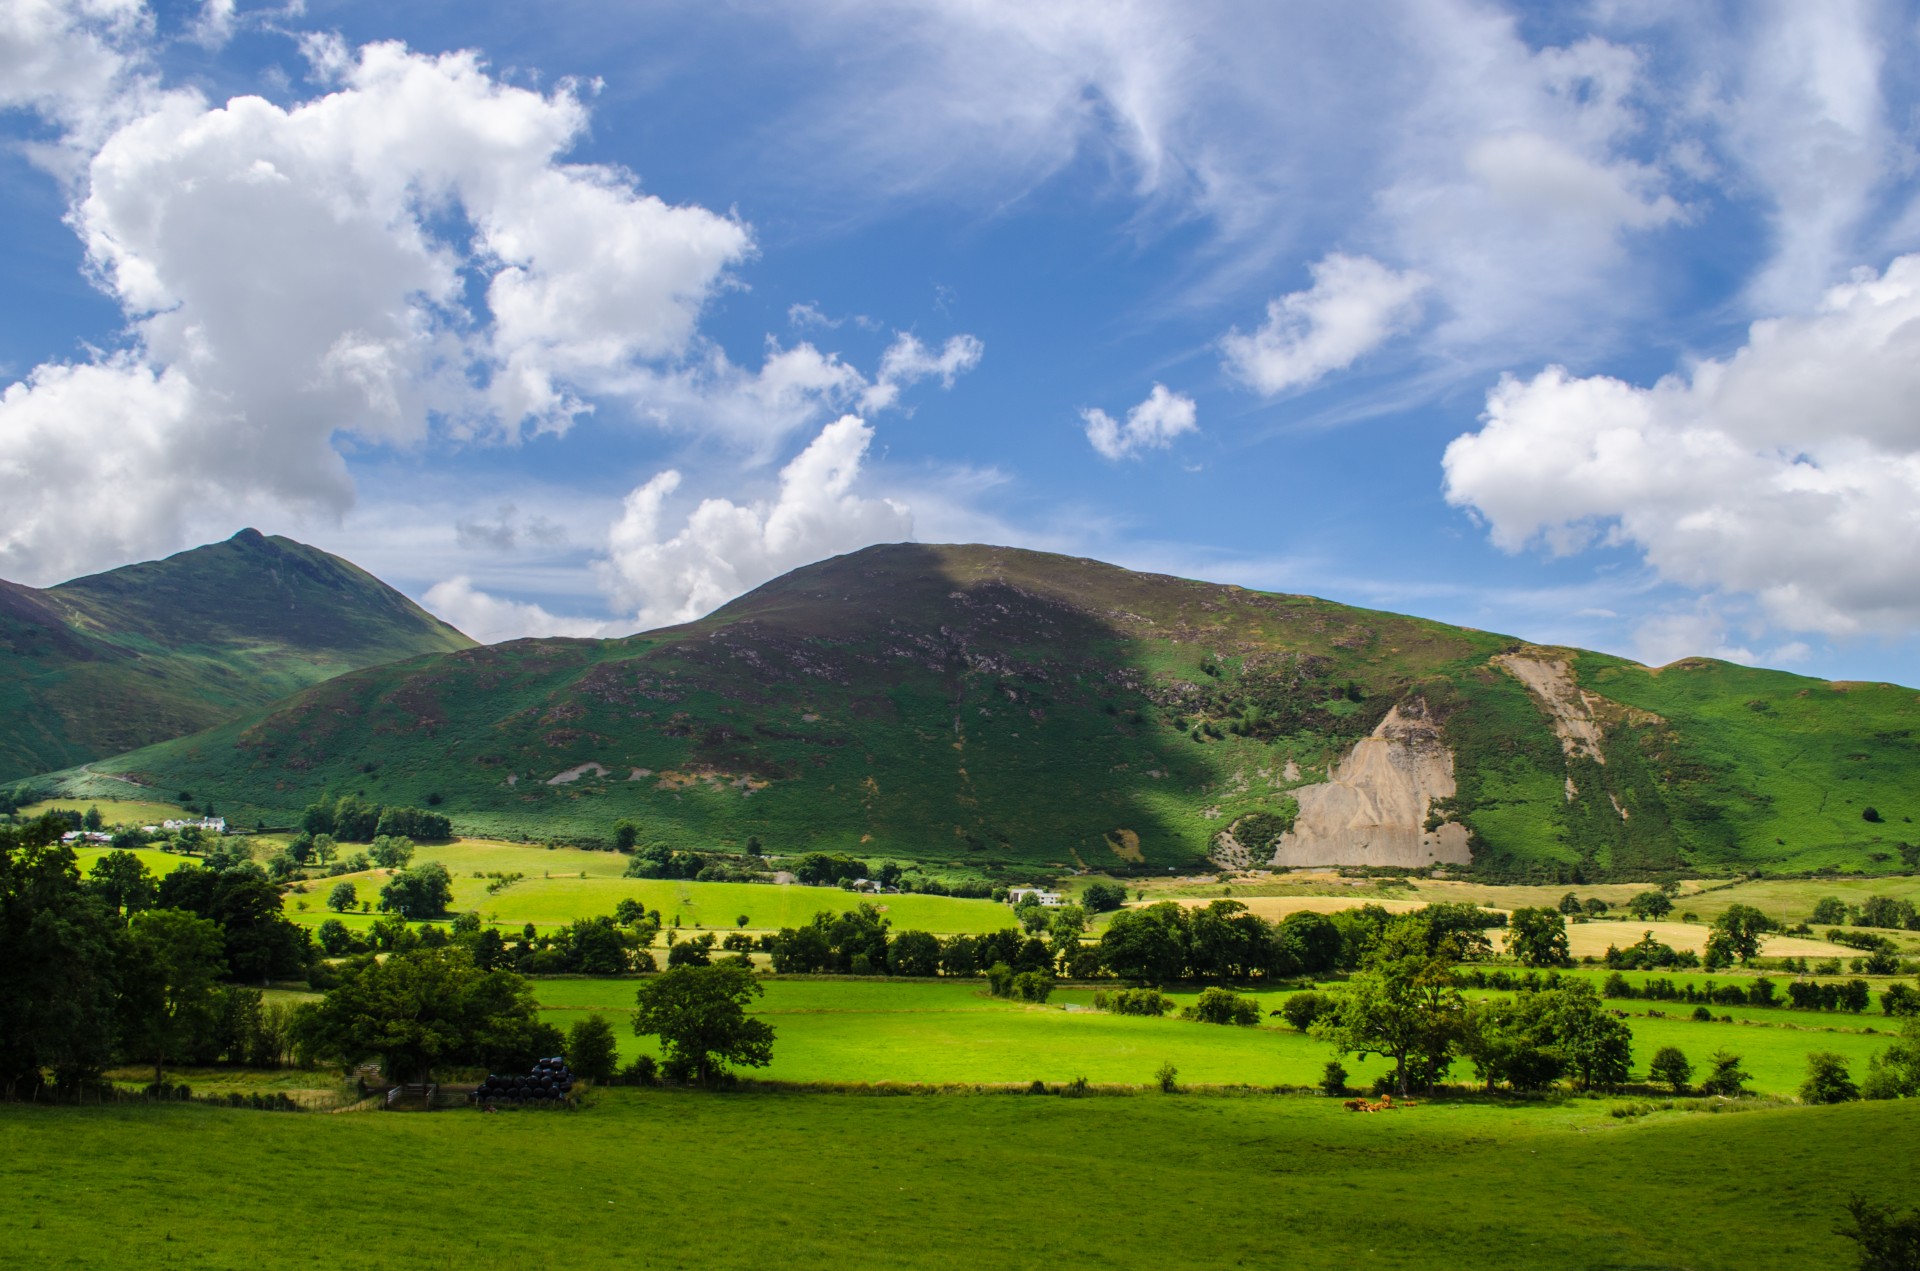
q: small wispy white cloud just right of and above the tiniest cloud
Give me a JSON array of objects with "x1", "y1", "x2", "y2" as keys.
[{"x1": 1221, "y1": 252, "x2": 1427, "y2": 394}]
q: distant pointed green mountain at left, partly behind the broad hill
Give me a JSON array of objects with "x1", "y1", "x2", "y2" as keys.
[{"x1": 0, "y1": 530, "x2": 472, "y2": 781}]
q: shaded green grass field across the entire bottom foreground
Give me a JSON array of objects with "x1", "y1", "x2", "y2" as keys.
[{"x1": 0, "y1": 1091, "x2": 1920, "y2": 1271}]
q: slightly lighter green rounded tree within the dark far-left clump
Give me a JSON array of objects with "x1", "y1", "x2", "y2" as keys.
[{"x1": 123, "y1": 910, "x2": 227, "y2": 1085}]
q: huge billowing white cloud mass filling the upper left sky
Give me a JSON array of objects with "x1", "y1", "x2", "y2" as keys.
[{"x1": 0, "y1": 33, "x2": 748, "y2": 582}]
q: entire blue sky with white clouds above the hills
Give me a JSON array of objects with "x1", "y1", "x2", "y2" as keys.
[{"x1": 0, "y1": 0, "x2": 1920, "y2": 683}]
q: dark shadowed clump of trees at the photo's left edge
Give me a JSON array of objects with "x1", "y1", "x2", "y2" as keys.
[{"x1": 0, "y1": 818, "x2": 313, "y2": 1096}]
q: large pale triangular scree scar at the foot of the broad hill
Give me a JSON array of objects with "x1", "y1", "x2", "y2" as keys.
[{"x1": 1273, "y1": 699, "x2": 1471, "y2": 868}]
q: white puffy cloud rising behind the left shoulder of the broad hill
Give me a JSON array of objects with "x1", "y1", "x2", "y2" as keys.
[{"x1": 597, "y1": 415, "x2": 914, "y2": 628}]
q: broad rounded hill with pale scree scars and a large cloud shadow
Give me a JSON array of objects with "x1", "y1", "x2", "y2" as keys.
[{"x1": 56, "y1": 543, "x2": 1920, "y2": 881}]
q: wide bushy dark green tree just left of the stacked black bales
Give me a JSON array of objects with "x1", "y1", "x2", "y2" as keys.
[{"x1": 294, "y1": 947, "x2": 541, "y2": 1081}]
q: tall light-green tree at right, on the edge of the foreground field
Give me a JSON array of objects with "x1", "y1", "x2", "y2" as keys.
[{"x1": 1313, "y1": 916, "x2": 1465, "y2": 1094}]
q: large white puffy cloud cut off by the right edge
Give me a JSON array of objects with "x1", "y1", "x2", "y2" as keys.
[{"x1": 1444, "y1": 255, "x2": 1920, "y2": 643}]
